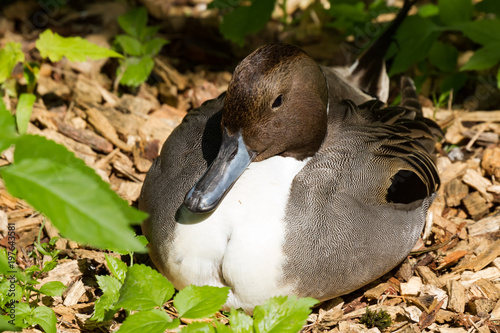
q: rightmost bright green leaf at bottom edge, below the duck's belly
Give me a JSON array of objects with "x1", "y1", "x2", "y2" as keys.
[{"x1": 253, "y1": 296, "x2": 318, "y2": 333}]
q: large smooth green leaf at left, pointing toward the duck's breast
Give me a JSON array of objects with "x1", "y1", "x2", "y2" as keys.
[{"x1": 1, "y1": 135, "x2": 146, "y2": 251}]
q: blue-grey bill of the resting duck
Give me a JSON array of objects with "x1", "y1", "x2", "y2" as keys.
[{"x1": 184, "y1": 129, "x2": 257, "y2": 214}]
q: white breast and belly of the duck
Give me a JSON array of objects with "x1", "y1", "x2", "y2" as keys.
[{"x1": 168, "y1": 156, "x2": 307, "y2": 309}]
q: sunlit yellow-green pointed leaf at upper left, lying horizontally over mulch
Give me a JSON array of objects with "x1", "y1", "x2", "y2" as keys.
[{"x1": 36, "y1": 29, "x2": 123, "y2": 62}]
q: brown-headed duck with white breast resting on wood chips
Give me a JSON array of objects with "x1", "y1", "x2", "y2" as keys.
[{"x1": 139, "y1": 2, "x2": 440, "y2": 314}]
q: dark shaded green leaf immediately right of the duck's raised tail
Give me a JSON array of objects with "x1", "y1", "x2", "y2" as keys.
[{"x1": 389, "y1": 15, "x2": 440, "y2": 76}]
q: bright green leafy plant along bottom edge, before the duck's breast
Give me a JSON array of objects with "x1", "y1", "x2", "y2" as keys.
[{"x1": 92, "y1": 255, "x2": 317, "y2": 333}]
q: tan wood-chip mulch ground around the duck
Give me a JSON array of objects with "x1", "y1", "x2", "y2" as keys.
[{"x1": 0, "y1": 1, "x2": 500, "y2": 333}]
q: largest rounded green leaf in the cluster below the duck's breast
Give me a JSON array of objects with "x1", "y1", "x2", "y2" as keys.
[{"x1": 116, "y1": 264, "x2": 175, "y2": 310}]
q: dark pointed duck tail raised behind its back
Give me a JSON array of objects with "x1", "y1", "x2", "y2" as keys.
[{"x1": 348, "y1": 0, "x2": 416, "y2": 103}]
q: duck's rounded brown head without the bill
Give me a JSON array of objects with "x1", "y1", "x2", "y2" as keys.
[{"x1": 221, "y1": 44, "x2": 328, "y2": 161}]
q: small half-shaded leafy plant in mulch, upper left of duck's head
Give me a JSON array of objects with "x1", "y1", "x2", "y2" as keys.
[{"x1": 114, "y1": 7, "x2": 168, "y2": 87}]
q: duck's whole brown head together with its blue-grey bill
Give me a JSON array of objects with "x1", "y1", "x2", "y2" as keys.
[{"x1": 184, "y1": 44, "x2": 328, "y2": 213}]
